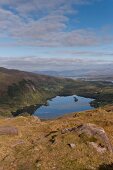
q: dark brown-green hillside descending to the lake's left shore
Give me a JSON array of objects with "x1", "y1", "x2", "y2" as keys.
[{"x1": 0, "y1": 68, "x2": 73, "y2": 115}]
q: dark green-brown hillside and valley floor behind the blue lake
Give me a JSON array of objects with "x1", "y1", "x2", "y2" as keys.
[{"x1": 0, "y1": 68, "x2": 113, "y2": 116}]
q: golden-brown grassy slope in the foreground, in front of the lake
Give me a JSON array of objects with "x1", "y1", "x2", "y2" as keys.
[{"x1": 0, "y1": 106, "x2": 113, "y2": 170}]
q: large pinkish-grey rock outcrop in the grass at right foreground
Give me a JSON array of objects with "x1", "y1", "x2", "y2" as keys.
[{"x1": 62, "y1": 123, "x2": 113, "y2": 153}]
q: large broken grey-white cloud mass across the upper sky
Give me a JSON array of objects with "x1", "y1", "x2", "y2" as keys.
[{"x1": 0, "y1": 0, "x2": 113, "y2": 47}]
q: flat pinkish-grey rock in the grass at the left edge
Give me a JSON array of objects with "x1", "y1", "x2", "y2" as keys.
[{"x1": 0, "y1": 126, "x2": 18, "y2": 135}]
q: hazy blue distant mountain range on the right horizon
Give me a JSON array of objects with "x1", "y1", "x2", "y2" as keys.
[{"x1": 35, "y1": 64, "x2": 113, "y2": 81}]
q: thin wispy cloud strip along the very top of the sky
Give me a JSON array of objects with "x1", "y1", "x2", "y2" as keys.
[{"x1": 0, "y1": 0, "x2": 89, "y2": 14}]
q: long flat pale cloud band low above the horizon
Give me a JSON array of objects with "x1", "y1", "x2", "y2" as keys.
[{"x1": 0, "y1": 56, "x2": 113, "y2": 73}]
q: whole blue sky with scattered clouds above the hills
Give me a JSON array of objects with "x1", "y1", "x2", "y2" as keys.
[{"x1": 0, "y1": 0, "x2": 113, "y2": 69}]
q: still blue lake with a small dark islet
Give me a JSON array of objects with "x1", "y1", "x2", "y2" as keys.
[{"x1": 34, "y1": 95, "x2": 93, "y2": 119}]
